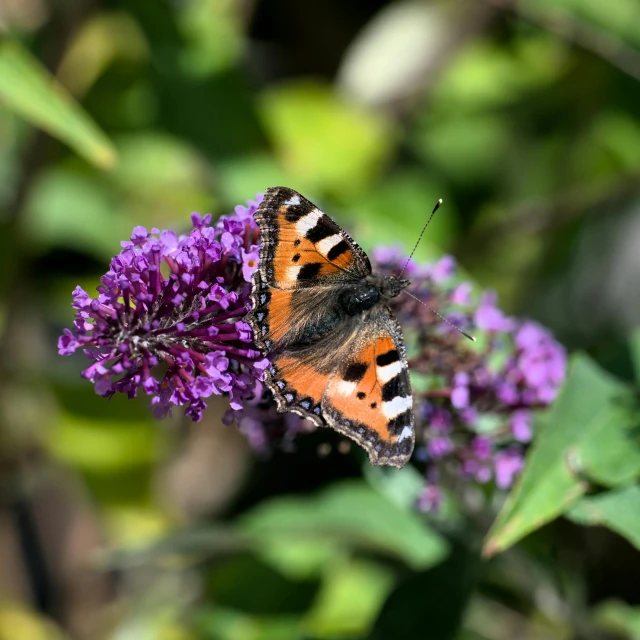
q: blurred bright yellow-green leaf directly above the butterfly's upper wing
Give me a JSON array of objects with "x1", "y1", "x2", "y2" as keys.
[{"x1": 261, "y1": 82, "x2": 395, "y2": 197}]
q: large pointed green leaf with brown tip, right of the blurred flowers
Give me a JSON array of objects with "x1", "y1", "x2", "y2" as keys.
[{"x1": 484, "y1": 355, "x2": 628, "y2": 555}]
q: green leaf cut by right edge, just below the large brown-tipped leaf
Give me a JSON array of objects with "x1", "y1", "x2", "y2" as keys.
[{"x1": 567, "y1": 486, "x2": 640, "y2": 549}]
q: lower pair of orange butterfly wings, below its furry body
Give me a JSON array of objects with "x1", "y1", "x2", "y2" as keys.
[{"x1": 267, "y1": 308, "x2": 414, "y2": 468}]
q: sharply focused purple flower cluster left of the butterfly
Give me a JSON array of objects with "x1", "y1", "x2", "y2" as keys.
[{"x1": 58, "y1": 195, "x2": 268, "y2": 420}]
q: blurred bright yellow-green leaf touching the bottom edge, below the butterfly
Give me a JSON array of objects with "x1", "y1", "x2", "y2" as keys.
[{"x1": 304, "y1": 560, "x2": 394, "y2": 638}]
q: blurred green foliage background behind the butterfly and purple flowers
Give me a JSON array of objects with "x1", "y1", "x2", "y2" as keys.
[{"x1": 0, "y1": 0, "x2": 640, "y2": 640}]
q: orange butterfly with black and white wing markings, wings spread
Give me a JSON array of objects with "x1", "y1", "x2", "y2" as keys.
[{"x1": 247, "y1": 187, "x2": 415, "y2": 468}]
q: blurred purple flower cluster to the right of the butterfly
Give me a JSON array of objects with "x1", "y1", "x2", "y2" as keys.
[{"x1": 374, "y1": 248, "x2": 566, "y2": 510}]
